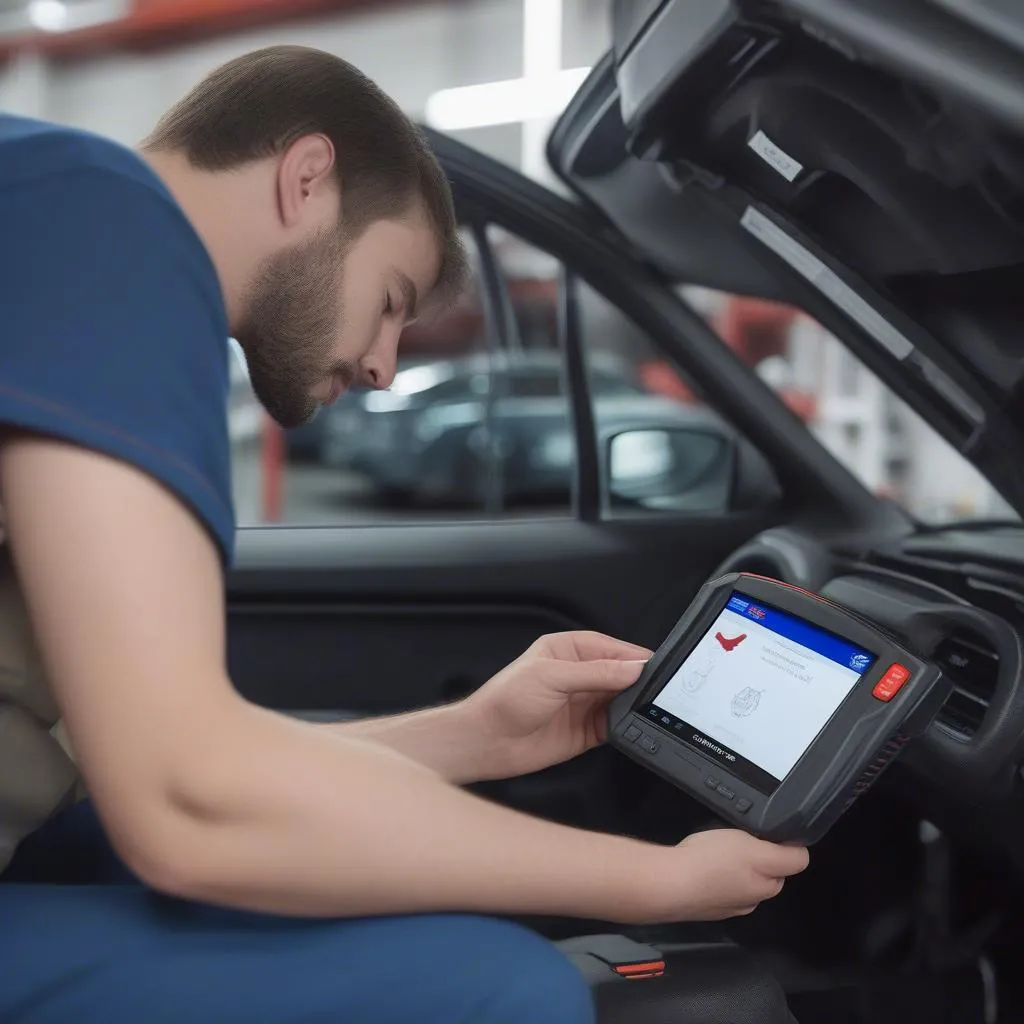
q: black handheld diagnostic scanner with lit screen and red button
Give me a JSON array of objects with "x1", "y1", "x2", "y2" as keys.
[{"x1": 608, "y1": 573, "x2": 952, "y2": 844}]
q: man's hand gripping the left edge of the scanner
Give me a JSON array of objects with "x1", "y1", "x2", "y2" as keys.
[{"x1": 464, "y1": 632, "x2": 651, "y2": 777}]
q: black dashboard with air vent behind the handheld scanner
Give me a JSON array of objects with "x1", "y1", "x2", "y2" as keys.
[{"x1": 719, "y1": 526, "x2": 1024, "y2": 873}]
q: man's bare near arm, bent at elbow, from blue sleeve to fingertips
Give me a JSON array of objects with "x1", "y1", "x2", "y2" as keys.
[{"x1": 0, "y1": 436, "x2": 803, "y2": 921}]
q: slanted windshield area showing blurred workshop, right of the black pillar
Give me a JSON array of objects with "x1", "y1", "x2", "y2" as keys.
[{"x1": 680, "y1": 287, "x2": 1020, "y2": 525}]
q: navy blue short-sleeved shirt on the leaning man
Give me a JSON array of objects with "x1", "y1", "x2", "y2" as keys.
[{"x1": 0, "y1": 115, "x2": 234, "y2": 564}]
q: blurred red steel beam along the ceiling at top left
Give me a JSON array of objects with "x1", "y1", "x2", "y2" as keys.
[{"x1": 0, "y1": 0, "x2": 410, "y2": 60}]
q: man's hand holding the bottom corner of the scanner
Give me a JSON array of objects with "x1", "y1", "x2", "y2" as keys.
[{"x1": 644, "y1": 828, "x2": 809, "y2": 923}]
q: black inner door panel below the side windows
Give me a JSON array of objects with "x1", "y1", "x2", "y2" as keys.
[{"x1": 228, "y1": 513, "x2": 769, "y2": 714}]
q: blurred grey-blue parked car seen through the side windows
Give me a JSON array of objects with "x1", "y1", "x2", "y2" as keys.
[{"x1": 307, "y1": 350, "x2": 749, "y2": 507}]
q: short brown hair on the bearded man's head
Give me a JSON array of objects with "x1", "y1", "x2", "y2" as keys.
[{"x1": 142, "y1": 46, "x2": 466, "y2": 303}]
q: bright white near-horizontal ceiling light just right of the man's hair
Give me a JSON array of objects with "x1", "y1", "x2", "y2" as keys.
[{"x1": 425, "y1": 68, "x2": 590, "y2": 131}]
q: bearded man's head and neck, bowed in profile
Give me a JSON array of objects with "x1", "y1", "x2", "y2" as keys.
[{"x1": 142, "y1": 46, "x2": 465, "y2": 427}]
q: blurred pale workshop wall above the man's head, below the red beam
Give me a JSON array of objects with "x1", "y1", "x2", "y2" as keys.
[{"x1": 0, "y1": 0, "x2": 609, "y2": 172}]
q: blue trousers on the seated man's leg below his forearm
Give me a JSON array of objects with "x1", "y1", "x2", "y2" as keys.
[{"x1": 0, "y1": 805, "x2": 594, "y2": 1024}]
